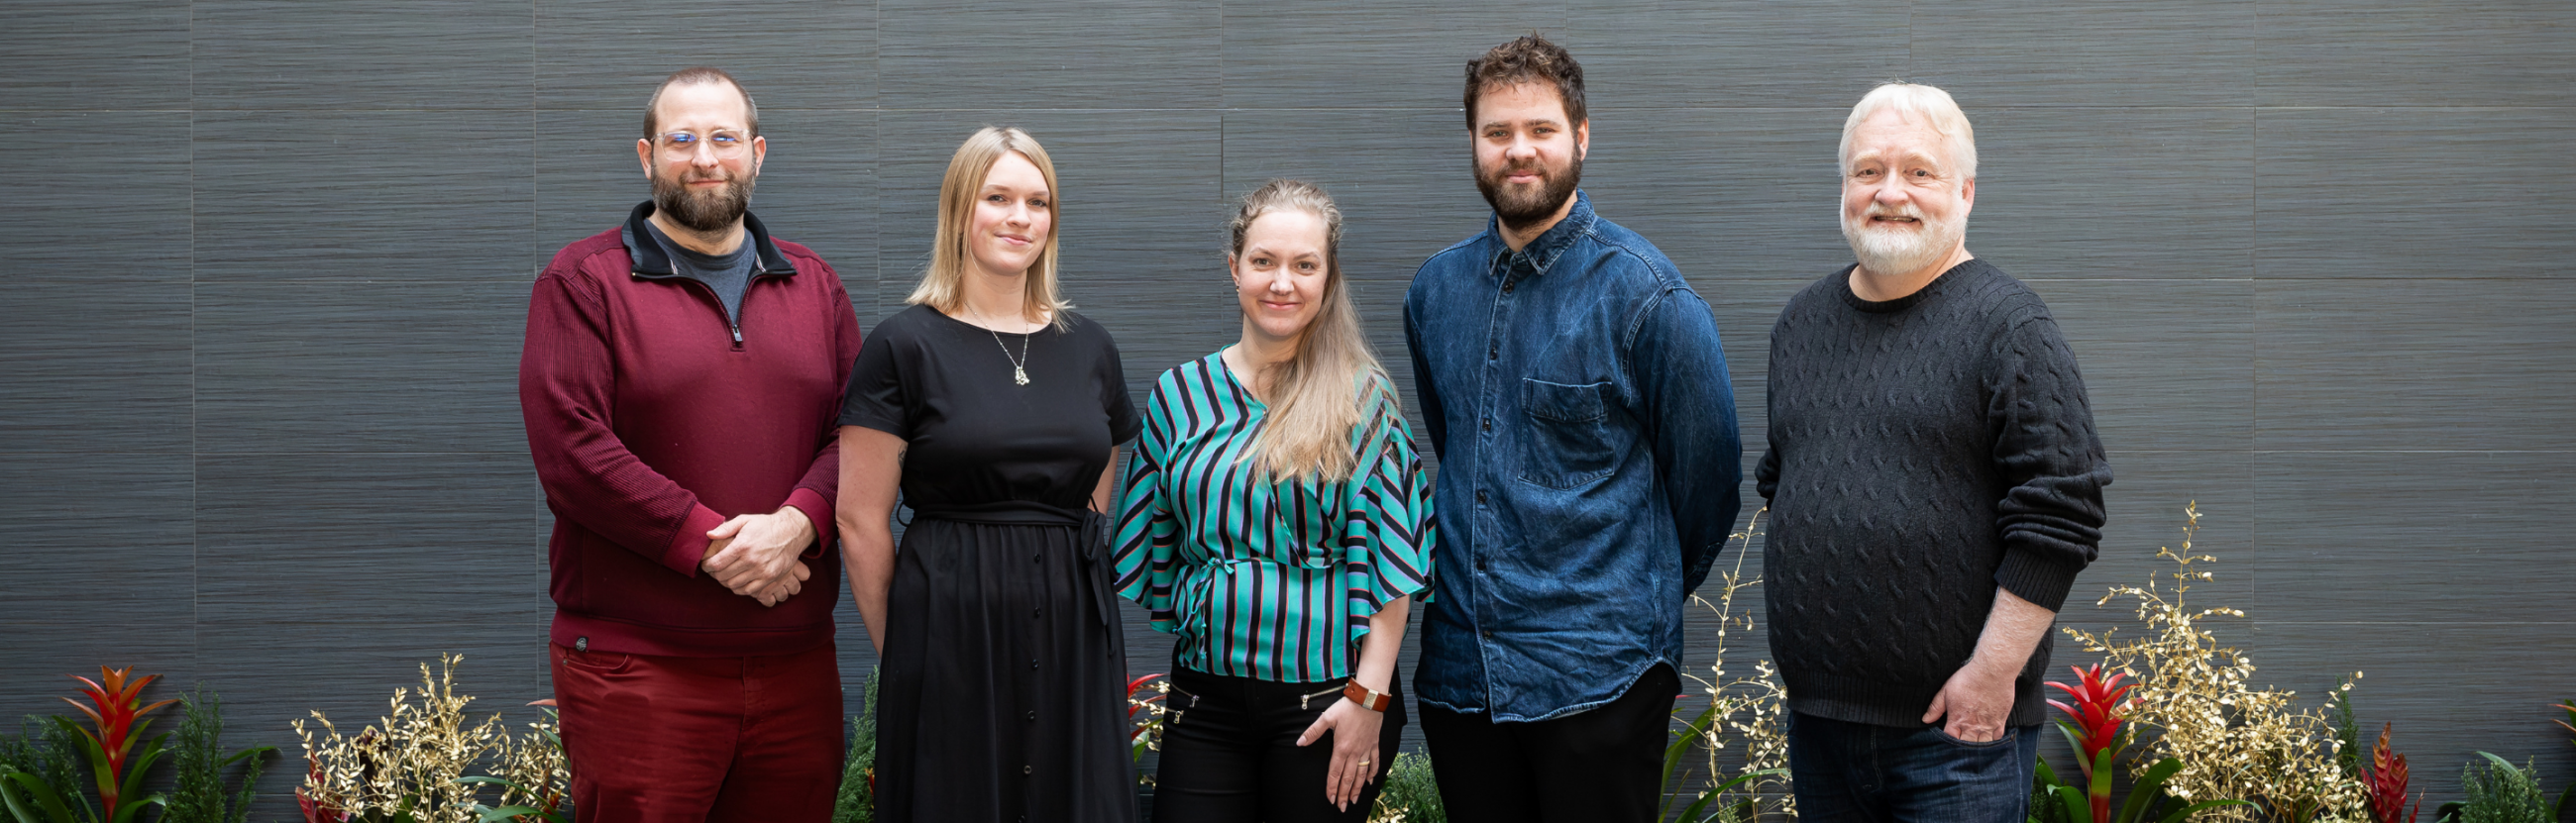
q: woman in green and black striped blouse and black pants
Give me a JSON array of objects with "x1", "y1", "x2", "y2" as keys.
[{"x1": 1113, "y1": 180, "x2": 1435, "y2": 823}]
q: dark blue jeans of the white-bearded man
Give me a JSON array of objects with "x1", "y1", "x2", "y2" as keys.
[{"x1": 1787, "y1": 712, "x2": 2040, "y2": 823}]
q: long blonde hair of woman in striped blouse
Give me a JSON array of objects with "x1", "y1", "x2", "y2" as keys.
[{"x1": 1227, "y1": 180, "x2": 1404, "y2": 481}]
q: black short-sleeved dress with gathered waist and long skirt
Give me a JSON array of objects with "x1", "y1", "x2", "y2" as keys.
[{"x1": 840, "y1": 306, "x2": 1141, "y2": 823}]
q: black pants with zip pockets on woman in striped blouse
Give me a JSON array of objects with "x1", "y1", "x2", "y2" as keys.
[{"x1": 1154, "y1": 667, "x2": 1411, "y2": 823}]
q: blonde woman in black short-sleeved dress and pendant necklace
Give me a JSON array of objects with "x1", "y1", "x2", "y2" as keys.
[{"x1": 837, "y1": 129, "x2": 1138, "y2": 823}]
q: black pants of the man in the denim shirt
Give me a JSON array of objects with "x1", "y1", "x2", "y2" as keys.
[{"x1": 1422, "y1": 664, "x2": 1682, "y2": 823}]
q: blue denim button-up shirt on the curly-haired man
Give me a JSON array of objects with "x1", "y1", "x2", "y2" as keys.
[{"x1": 1404, "y1": 193, "x2": 1744, "y2": 723}]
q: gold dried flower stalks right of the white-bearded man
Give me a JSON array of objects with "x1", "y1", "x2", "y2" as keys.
[{"x1": 2066, "y1": 501, "x2": 2367, "y2": 820}]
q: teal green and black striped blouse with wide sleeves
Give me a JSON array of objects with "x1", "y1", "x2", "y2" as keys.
[{"x1": 1111, "y1": 350, "x2": 1438, "y2": 681}]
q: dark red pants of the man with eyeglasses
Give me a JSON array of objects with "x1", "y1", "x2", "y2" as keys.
[{"x1": 554, "y1": 643, "x2": 845, "y2": 823}]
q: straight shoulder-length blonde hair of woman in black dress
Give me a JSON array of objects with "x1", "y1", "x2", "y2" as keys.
[{"x1": 905, "y1": 126, "x2": 1074, "y2": 329}]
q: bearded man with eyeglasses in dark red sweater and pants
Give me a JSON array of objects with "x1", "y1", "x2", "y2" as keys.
[{"x1": 518, "y1": 67, "x2": 858, "y2": 820}]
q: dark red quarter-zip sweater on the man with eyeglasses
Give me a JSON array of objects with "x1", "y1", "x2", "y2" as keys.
[{"x1": 518, "y1": 203, "x2": 858, "y2": 656}]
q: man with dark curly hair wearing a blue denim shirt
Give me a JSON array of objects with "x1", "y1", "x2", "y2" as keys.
[{"x1": 1404, "y1": 36, "x2": 1744, "y2": 823}]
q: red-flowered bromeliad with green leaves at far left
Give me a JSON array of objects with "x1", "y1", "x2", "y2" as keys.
[{"x1": 0, "y1": 667, "x2": 177, "y2": 823}]
